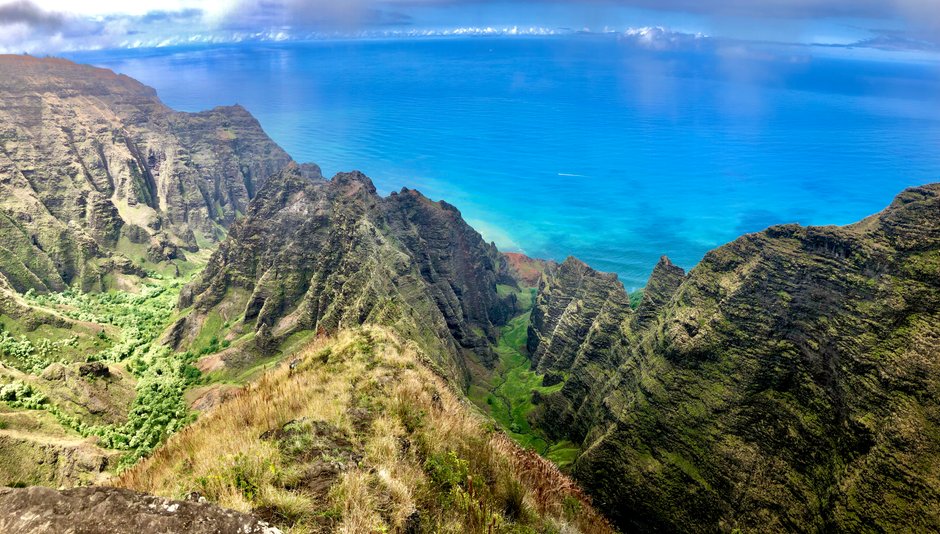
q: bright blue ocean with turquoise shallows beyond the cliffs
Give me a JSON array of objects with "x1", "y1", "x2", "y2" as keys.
[{"x1": 72, "y1": 36, "x2": 940, "y2": 289}]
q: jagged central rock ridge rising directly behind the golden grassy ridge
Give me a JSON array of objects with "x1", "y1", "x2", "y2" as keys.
[{"x1": 174, "y1": 165, "x2": 511, "y2": 384}]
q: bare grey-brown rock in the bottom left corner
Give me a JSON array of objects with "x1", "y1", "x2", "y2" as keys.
[{"x1": 0, "y1": 487, "x2": 280, "y2": 534}]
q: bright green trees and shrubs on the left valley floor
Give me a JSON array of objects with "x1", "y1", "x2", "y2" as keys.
[{"x1": 0, "y1": 274, "x2": 209, "y2": 467}]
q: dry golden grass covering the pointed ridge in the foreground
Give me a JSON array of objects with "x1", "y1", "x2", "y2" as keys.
[{"x1": 112, "y1": 327, "x2": 611, "y2": 533}]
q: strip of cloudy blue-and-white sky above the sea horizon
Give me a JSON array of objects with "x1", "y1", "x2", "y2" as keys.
[{"x1": 0, "y1": 0, "x2": 940, "y2": 54}]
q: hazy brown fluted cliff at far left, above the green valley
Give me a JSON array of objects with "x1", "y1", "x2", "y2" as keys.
[{"x1": 0, "y1": 56, "x2": 290, "y2": 291}]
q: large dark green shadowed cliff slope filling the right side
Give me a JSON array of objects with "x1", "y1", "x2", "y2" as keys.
[{"x1": 530, "y1": 184, "x2": 940, "y2": 531}]
